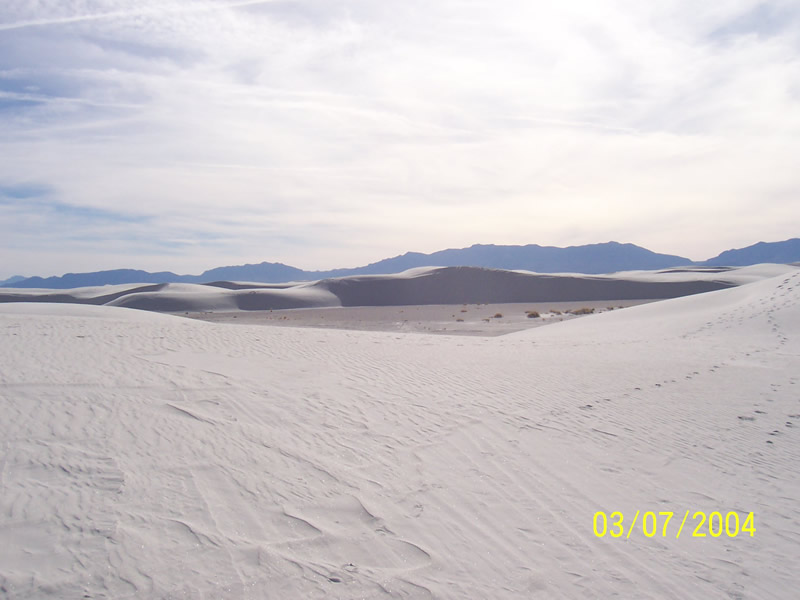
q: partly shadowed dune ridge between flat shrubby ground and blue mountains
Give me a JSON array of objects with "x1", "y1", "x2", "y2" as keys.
[{"x1": 0, "y1": 265, "x2": 794, "y2": 312}]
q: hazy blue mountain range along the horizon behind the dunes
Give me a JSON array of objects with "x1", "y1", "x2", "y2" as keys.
[{"x1": 0, "y1": 238, "x2": 800, "y2": 289}]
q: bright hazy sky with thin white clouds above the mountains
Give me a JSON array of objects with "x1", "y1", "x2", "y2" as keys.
[{"x1": 0, "y1": 0, "x2": 800, "y2": 279}]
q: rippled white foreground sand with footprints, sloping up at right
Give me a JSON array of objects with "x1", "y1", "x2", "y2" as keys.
[{"x1": 0, "y1": 269, "x2": 800, "y2": 599}]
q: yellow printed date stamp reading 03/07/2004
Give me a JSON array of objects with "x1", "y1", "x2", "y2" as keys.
[{"x1": 593, "y1": 510, "x2": 756, "y2": 539}]
